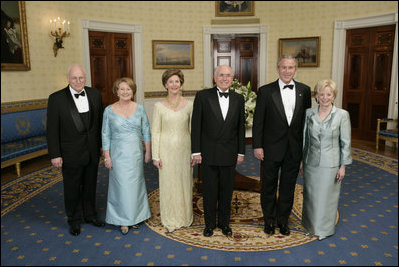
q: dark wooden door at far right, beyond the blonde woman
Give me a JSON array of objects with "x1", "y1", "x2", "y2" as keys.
[{"x1": 342, "y1": 25, "x2": 395, "y2": 141}]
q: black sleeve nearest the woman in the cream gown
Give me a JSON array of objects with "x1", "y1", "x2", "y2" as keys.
[{"x1": 191, "y1": 92, "x2": 202, "y2": 153}]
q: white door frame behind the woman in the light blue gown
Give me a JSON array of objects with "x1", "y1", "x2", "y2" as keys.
[{"x1": 82, "y1": 19, "x2": 144, "y2": 103}]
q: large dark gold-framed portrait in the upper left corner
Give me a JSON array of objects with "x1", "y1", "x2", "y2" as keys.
[{"x1": 1, "y1": 1, "x2": 30, "y2": 71}]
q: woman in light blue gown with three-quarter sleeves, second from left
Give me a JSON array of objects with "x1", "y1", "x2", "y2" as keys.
[{"x1": 102, "y1": 78, "x2": 151, "y2": 235}]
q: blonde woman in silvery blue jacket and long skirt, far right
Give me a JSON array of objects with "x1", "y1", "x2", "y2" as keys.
[{"x1": 301, "y1": 80, "x2": 352, "y2": 240}]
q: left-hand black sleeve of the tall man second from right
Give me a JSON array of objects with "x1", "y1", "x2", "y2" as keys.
[{"x1": 252, "y1": 87, "x2": 266, "y2": 148}]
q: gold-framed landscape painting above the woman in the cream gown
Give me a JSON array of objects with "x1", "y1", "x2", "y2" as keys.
[{"x1": 152, "y1": 40, "x2": 194, "y2": 69}]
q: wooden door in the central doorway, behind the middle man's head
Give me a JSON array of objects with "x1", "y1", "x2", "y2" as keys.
[{"x1": 213, "y1": 36, "x2": 258, "y2": 92}]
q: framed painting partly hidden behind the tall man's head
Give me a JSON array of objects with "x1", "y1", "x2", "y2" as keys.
[{"x1": 279, "y1": 37, "x2": 320, "y2": 67}]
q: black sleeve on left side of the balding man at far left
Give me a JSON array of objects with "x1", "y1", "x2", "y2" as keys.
[{"x1": 46, "y1": 94, "x2": 61, "y2": 159}]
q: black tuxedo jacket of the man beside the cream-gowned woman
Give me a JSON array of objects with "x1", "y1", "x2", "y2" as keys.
[{"x1": 191, "y1": 87, "x2": 245, "y2": 166}]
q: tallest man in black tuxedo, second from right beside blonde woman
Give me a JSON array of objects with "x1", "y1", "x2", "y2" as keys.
[{"x1": 252, "y1": 55, "x2": 312, "y2": 235}]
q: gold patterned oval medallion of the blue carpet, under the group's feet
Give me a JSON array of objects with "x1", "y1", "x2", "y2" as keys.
[{"x1": 146, "y1": 184, "x2": 317, "y2": 252}]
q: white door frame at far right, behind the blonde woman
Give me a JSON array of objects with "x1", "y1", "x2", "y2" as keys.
[{"x1": 331, "y1": 13, "x2": 398, "y2": 118}]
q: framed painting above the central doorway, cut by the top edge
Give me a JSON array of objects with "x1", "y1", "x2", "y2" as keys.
[{"x1": 215, "y1": 1, "x2": 255, "y2": 17}]
